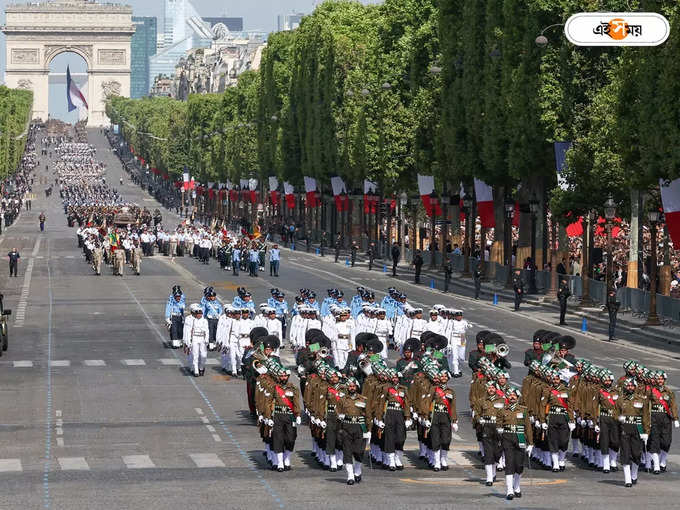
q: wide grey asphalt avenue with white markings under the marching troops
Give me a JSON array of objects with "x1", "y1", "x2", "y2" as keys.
[{"x1": 0, "y1": 131, "x2": 680, "y2": 509}]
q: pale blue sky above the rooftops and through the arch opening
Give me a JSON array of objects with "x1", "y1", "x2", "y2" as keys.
[{"x1": 0, "y1": 0, "x2": 380, "y2": 121}]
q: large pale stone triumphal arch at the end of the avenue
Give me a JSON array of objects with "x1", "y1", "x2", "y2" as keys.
[{"x1": 2, "y1": 0, "x2": 135, "y2": 126}]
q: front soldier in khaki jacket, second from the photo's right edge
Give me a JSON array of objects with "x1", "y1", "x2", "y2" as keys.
[{"x1": 616, "y1": 378, "x2": 650, "y2": 487}]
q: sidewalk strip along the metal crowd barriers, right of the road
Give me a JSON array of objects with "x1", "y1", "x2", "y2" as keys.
[{"x1": 281, "y1": 237, "x2": 680, "y2": 348}]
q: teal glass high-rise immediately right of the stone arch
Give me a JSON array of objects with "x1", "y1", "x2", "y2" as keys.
[{"x1": 130, "y1": 16, "x2": 157, "y2": 98}]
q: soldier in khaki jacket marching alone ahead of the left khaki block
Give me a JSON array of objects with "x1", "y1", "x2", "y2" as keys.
[{"x1": 336, "y1": 377, "x2": 372, "y2": 485}]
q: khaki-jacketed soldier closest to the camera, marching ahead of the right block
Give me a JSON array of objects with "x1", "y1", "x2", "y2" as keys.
[{"x1": 496, "y1": 388, "x2": 534, "y2": 500}]
